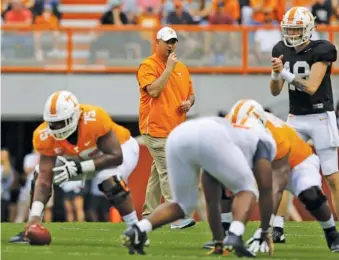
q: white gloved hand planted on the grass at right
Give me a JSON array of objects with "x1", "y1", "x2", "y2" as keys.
[{"x1": 246, "y1": 228, "x2": 274, "y2": 256}]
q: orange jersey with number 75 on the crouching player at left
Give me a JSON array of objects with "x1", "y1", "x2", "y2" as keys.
[{"x1": 33, "y1": 105, "x2": 131, "y2": 160}]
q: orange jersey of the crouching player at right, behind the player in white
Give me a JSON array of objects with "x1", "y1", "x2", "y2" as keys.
[{"x1": 265, "y1": 113, "x2": 313, "y2": 169}]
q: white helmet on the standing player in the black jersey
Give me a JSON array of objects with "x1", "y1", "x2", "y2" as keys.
[{"x1": 281, "y1": 6, "x2": 315, "y2": 47}]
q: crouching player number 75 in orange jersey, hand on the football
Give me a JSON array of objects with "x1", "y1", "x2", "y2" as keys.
[{"x1": 9, "y1": 91, "x2": 139, "y2": 244}]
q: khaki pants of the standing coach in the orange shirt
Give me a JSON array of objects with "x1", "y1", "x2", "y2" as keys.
[{"x1": 142, "y1": 135, "x2": 172, "y2": 216}]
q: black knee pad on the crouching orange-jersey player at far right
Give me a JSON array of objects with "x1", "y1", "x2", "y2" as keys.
[{"x1": 298, "y1": 186, "x2": 327, "y2": 211}]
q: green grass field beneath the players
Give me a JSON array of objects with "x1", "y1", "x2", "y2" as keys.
[{"x1": 1, "y1": 222, "x2": 339, "y2": 260}]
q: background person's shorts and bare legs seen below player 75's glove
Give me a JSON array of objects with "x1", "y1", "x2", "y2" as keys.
[{"x1": 60, "y1": 181, "x2": 85, "y2": 222}]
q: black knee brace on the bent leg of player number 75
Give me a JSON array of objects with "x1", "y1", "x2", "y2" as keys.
[{"x1": 98, "y1": 175, "x2": 130, "y2": 205}]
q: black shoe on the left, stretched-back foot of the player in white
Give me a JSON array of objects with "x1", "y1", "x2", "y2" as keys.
[{"x1": 120, "y1": 225, "x2": 147, "y2": 255}]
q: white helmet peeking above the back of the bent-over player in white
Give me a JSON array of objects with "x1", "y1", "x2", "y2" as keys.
[{"x1": 227, "y1": 99, "x2": 267, "y2": 129}]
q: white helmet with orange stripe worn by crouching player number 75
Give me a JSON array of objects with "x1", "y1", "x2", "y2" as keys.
[{"x1": 43, "y1": 91, "x2": 81, "y2": 140}]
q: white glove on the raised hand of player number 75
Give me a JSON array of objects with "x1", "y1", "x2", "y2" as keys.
[{"x1": 53, "y1": 156, "x2": 80, "y2": 185}]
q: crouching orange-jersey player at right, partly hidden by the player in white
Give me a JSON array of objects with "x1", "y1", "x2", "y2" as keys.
[{"x1": 229, "y1": 99, "x2": 339, "y2": 252}]
